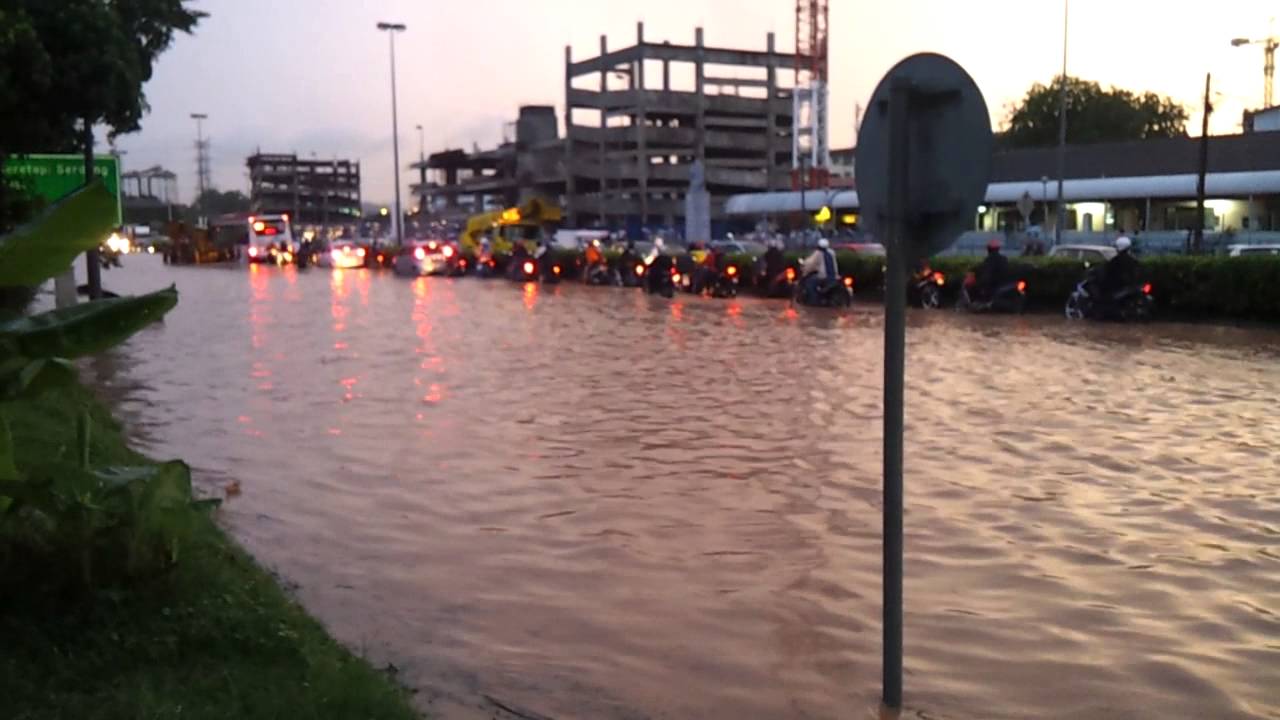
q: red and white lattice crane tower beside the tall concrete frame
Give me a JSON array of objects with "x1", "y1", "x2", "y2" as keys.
[{"x1": 791, "y1": 0, "x2": 831, "y2": 190}]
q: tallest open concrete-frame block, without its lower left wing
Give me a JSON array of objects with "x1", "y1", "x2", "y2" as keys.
[{"x1": 564, "y1": 23, "x2": 795, "y2": 229}]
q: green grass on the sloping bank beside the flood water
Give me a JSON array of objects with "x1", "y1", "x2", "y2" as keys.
[{"x1": 0, "y1": 387, "x2": 417, "y2": 720}]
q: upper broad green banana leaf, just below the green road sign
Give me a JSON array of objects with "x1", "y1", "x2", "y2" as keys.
[{"x1": 0, "y1": 181, "x2": 115, "y2": 287}]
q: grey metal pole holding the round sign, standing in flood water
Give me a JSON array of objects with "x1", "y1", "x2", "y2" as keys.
[{"x1": 882, "y1": 82, "x2": 911, "y2": 710}]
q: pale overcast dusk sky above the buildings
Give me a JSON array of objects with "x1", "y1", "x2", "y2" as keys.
[{"x1": 118, "y1": 0, "x2": 1280, "y2": 202}]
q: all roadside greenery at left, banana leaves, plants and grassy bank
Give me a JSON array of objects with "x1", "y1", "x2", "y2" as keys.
[{"x1": 0, "y1": 183, "x2": 415, "y2": 720}]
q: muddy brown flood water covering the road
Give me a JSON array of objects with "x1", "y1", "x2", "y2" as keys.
[{"x1": 87, "y1": 258, "x2": 1280, "y2": 720}]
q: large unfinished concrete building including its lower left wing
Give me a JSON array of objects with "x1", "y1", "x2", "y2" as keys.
[{"x1": 413, "y1": 23, "x2": 797, "y2": 232}]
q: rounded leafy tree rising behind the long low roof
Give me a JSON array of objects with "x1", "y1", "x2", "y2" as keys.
[{"x1": 1000, "y1": 76, "x2": 1188, "y2": 147}]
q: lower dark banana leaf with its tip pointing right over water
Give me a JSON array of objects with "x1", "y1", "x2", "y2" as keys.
[{"x1": 0, "y1": 286, "x2": 178, "y2": 359}]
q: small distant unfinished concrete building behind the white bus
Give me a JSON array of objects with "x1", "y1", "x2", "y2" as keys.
[{"x1": 247, "y1": 152, "x2": 360, "y2": 227}]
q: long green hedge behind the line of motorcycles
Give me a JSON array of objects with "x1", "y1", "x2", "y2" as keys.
[{"x1": 481, "y1": 249, "x2": 1280, "y2": 320}]
